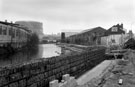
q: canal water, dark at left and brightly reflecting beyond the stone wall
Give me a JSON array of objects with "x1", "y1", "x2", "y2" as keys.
[{"x1": 0, "y1": 44, "x2": 61, "y2": 66}]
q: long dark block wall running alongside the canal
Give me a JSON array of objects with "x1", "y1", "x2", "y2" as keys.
[{"x1": 0, "y1": 49, "x2": 105, "y2": 87}]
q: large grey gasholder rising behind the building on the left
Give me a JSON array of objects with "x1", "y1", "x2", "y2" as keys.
[{"x1": 15, "y1": 21, "x2": 44, "y2": 39}]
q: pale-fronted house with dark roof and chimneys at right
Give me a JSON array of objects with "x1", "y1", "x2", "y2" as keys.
[{"x1": 101, "y1": 24, "x2": 126, "y2": 46}]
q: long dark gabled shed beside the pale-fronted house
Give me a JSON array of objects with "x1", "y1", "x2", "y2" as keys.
[{"x1": 67, "y1": 27, "x2": 106, "y2": 45}]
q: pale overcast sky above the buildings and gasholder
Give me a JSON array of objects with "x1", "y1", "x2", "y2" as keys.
[{"x1": 0, "y1": 0, "x2": 135, "y2": 34}]
